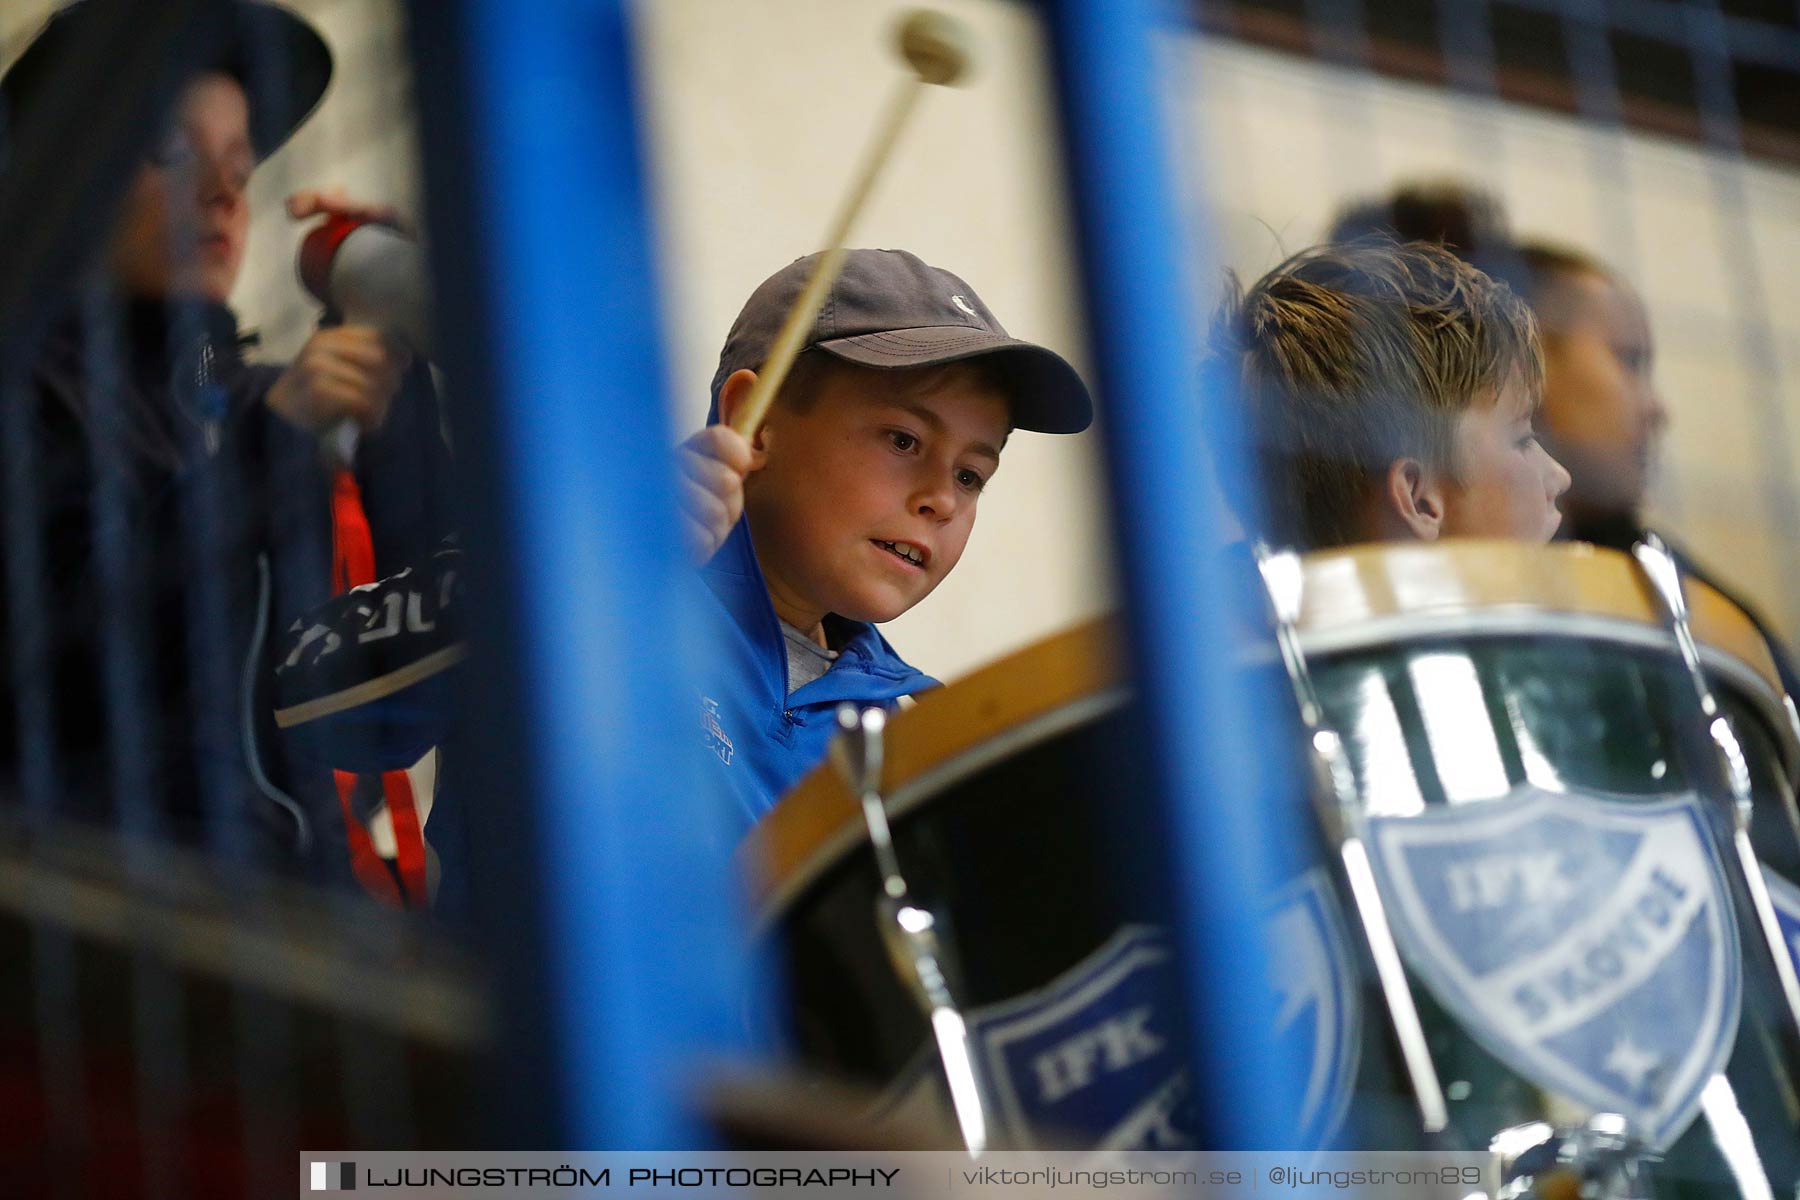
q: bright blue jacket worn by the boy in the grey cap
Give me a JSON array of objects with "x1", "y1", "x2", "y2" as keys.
[{"x1": 700, "y1": 520, "x2": 938, "y2": 824}]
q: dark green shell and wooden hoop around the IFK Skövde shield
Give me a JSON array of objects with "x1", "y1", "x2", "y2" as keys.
[{"x1": 1301, "y1": 547, "x2": 1800, "y2": 1195}]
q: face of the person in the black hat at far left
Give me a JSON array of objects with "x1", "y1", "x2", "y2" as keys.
[{"x1": 112, "y1": 72, "x2": 256, "y2": 302}]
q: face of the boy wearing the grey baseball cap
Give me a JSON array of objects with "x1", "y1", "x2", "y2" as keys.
[{"x1": 745, "y1": 369, "x2": 1010, "y2": 631}]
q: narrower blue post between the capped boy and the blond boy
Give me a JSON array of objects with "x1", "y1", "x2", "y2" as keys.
[{"x1": 1044, "y1": 0, "x2": 1300, "y2": 1150}]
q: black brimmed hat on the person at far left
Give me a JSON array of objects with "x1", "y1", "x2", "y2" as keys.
[{"x1": 0, "y1": 0, "x2": 331, "y2": 160}]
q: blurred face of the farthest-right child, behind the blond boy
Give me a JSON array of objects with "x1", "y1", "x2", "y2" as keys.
[{"x1": 1543, "y1": 272, "x2": 1669, "y2": 513}]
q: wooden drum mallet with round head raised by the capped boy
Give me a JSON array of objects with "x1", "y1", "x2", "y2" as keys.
[{"x1": 731, "y1": 9, "x2": 970, "y2": 439}]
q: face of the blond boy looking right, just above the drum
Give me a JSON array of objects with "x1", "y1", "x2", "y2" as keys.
[{"x1": 1442, "y1": 376, "x2": 1570, "y2": 542}]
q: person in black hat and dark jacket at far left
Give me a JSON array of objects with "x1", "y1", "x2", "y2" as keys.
[{"x1": 0, "y1": 4, "x2": 443, "y2": 878}]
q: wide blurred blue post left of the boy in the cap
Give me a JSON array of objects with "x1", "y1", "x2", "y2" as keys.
[{"x1": 412, "y1": 0, "x2": 743, "y2": 1150}]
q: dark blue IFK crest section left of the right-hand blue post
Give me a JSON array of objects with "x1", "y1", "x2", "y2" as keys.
[{"x1": 968, "y1": 925, "x2": 1193, "y2": 1150}]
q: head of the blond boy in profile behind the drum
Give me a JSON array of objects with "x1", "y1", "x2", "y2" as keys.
[{"x1": 1213, "y1": 239, "x2": 1570, "y2": 549}]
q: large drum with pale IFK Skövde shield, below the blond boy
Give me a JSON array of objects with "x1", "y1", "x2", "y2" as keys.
[{"x1": 1298, "y1": 542, "x2": 1800, "y2": 1196}]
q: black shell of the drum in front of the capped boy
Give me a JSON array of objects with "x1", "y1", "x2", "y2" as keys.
[{"x1": 781, "y1": 711, "x2": 1154, "y2": 1087}]
